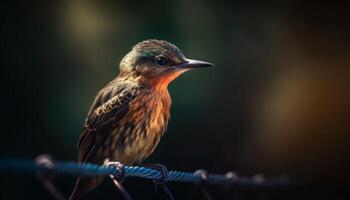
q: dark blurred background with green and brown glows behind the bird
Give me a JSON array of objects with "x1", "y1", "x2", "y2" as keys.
[{"x1": 0, "y1": 0, "x2": 350, "y2": 199}]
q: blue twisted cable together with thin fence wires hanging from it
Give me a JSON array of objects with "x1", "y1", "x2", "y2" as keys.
[{"x1": 0, "y1": 155, "x2": 295, "y2": 200}]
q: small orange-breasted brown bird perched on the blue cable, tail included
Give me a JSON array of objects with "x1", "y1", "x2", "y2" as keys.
[{"x1": 70, "y1": 39, "x2": 213, "y2": 200}]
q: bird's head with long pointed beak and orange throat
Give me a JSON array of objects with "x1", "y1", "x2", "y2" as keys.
[{"x1": 120, "y1": 40, "x2": 213, "y2": 87}]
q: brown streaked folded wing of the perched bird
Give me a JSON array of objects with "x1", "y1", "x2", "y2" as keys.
[{"x1": 78, "y1": 85, "x2": 138, "y2": 162}]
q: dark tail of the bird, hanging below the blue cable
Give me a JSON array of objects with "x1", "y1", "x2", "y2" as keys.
[{"x1": 69, "y1": 177, "x2": 103, "y2": 200}]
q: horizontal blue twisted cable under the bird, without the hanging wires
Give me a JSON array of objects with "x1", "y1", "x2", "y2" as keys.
[{"x1": 0, "y1": 155, "x2": 292, "y2": 188}]
